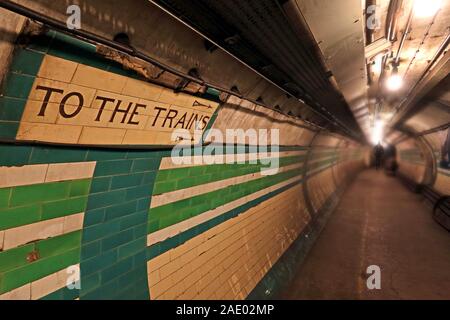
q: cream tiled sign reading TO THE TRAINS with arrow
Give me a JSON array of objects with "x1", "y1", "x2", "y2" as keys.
[{"x1": 16, "y1": 55, "x2": 218, "y2": 145}]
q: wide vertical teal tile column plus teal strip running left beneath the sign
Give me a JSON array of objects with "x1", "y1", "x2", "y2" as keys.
[{"x1": 0, "y1": 144, "x2": 163, "y2": 299}]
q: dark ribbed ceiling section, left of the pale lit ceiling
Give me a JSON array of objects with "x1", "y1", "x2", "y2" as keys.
[{"x1": 152, "y1": 0, "x2": 363, "y2": 140}]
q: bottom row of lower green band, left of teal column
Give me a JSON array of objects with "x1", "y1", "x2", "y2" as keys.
[{"x1": 0, "y1": 248, "x2": 80, "y2": 294}]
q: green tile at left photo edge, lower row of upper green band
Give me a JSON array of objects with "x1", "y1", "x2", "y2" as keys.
[{"x1": 0, "y1": 205, "x2": 41, "y2": 230}]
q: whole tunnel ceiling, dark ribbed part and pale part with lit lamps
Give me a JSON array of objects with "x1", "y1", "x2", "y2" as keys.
[{"x1": 151, "y1": 0, "x2": 450, "y2": 143}]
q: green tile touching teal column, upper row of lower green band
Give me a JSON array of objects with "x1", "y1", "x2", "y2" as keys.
[{"x1": 36, "y1": 230, "x2": 81, "y2": 259}]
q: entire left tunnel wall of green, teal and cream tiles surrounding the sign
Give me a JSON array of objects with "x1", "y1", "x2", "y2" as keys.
[{"x1": 0, "y1": 28, "x2": 363, "y2": 299}]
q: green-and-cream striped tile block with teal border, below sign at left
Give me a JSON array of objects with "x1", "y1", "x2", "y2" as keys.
[{"x1": 0, "y1": 144, "x2": 160, "y2": 299}]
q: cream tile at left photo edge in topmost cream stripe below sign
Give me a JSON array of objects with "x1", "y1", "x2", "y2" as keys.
[{"x1": 0, "y1": 164, "x2": 48, "y2": 188}]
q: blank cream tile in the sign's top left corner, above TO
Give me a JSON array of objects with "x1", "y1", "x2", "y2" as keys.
[{"x1": 38, "y1": 54, "x2": 78, "y2": 82}]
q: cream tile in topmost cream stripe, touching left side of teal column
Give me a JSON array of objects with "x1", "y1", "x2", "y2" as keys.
[{"x1": 45, "y1": 161, "x2": 96, "y2": 182}]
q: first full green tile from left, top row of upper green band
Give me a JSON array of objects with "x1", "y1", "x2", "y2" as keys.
[{"x1": 10, "y1": 181, "x2": 71, "y2": 206}]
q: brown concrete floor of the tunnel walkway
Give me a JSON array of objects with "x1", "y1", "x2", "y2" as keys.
[{"x1": 282, "y1": 170, "x2": 450, "y2": 299}]
